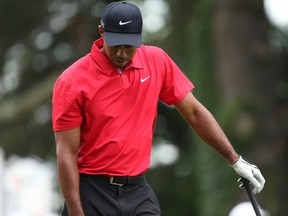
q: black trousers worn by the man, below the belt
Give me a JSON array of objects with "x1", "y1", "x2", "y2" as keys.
[{"x1": 62, "y1": 175, "x2": 161, "y2": 216}]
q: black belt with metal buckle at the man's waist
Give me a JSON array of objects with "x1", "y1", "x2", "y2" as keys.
[{"x1": 81, "y1": 174, "x2": 145, "y2": 186}]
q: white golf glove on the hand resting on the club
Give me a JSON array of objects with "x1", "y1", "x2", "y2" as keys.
[{"x1": 230, "y1": 156, "x2": 265, "y2": 195}]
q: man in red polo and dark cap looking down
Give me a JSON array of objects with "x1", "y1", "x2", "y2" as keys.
[{"x1": 52, "y1": 2, "x2": 265, "y2": 216}]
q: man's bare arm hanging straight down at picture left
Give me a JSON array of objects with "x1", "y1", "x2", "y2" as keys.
[{"x1": 54, "y1": 127, "x2": 84, "y2": 216}]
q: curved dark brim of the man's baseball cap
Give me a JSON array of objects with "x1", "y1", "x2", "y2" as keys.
[{"x1": 104, "y1": 32, "x2": 142, "y2": 47}]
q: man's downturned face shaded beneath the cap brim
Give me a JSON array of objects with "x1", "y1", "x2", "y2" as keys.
[{"x1": 102, "y1": 42, "x2": 137, "y2": 68}]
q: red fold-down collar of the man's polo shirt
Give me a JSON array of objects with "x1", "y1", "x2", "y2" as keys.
[{"x1": 90, "y1": 38, "x2": 143, "y2": 75}]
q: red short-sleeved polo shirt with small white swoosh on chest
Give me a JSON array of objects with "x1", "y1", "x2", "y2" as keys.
[{"x1": 52, "y1": 39, "x2": 194, "y2": 176}]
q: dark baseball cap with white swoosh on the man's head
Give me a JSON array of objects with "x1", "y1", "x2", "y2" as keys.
[{"x1": 101, "y1": 1, "x2": 143, "y2": 47}]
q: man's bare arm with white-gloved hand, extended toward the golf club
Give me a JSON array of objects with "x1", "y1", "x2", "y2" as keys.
[{"x1": 175, "y1": 92, "x2": 265, "y2": 193}]
